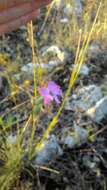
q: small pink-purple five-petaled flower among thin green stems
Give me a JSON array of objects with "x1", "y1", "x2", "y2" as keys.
[{"x1": 38, "y1": 81, "x2": 62, "y2": 105}]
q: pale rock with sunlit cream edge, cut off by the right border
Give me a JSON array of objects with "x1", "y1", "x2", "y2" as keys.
[{"x1": 86, "y1": 96, "x2": 107, "y2": 123}]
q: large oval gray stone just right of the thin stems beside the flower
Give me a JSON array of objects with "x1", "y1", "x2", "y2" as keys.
[{"x1": 65, "y1": 85, "x2": 103, "y2": 112}]
